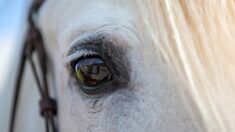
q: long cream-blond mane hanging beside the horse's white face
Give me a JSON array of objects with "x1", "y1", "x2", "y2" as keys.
[{"x1": 137, "y1": 0, "x2": 235, "y2": 132}]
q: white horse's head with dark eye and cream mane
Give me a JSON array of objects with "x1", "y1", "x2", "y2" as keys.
[{"x1": 10, "y1": 0, "x2": 235, "y2": 132}]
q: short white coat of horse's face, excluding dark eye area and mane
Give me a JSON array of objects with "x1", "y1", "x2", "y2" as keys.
[{"x1": 2, "y1": 0, "x2": 202, "y2": 132}]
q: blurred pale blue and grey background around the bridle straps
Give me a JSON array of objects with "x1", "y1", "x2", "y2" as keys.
[{"x1": 0, "y1": 0, "x2": 45, "y2": 132}]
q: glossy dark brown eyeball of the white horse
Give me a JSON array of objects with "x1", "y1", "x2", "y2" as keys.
[{"x1": 75, "y1": 57, "x2": 112, "y2": 87}]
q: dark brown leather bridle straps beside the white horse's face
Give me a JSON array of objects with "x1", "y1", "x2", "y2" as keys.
[{"x1": 9, "y1": 0, "x2": 58, "y2": 132}]
